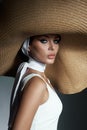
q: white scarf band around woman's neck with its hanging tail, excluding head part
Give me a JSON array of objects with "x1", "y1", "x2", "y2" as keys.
[{"x1": 12, "y1": 57, "x2": 46, "y2": 104}]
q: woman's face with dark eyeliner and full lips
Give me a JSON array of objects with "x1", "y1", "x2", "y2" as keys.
[{"x1": 29, "y1": 34, "x2": 60, "y2": 64}]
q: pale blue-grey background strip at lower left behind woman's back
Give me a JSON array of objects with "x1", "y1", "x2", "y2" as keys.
[{"x1": 0, "y1": 76, "x2": 14, "y2": 130}]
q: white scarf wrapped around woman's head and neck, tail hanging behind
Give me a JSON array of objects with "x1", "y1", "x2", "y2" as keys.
[{"x1": 12, "y1": 39, "x2": 46, "y2": 104}]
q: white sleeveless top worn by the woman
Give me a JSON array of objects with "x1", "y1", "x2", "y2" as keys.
[{"x1": 22, "y1": 74, "x2": 62, "y2": 130}]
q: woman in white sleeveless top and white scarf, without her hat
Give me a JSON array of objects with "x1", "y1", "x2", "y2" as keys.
[{"x1": 9, "y1": 34, "x2": 62, "y2": 130}]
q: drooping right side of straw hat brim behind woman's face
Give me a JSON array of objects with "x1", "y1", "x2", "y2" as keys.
[{"x1": 47, "y1": 34, "x2": 87, "y2": 94}]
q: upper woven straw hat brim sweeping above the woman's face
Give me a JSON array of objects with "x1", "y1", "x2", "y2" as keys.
[{"x1": 3, "y1": 0, "x2": 87, "y2": 35}]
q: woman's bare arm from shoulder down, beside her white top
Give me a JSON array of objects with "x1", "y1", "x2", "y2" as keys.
[{"x1": 12, "y1": 77, "x2": 46, "y2": 130}]
